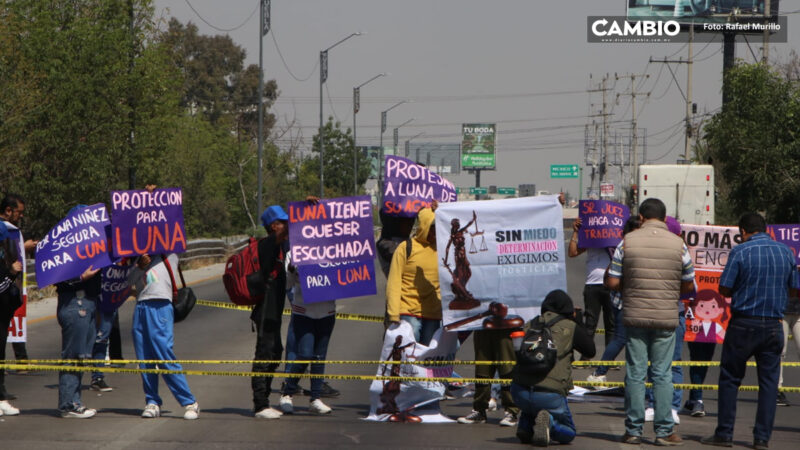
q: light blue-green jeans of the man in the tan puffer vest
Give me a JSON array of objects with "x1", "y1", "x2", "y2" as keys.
[{"x1": 625, "y1": 327, "x2": 676, "y2": 437}]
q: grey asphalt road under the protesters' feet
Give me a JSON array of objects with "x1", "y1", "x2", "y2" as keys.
[{"x1": 0, "y1": 257, "x2": 800, "y2": 450}]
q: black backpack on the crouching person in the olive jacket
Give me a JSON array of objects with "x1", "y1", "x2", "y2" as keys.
[{"x1": 517, "y1": 316, "x2": 564, "y2": 376}]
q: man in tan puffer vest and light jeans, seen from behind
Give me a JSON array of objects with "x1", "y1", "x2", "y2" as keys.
[{"x1": 608, "y1": 198, "x2": 694, "y2": 445}]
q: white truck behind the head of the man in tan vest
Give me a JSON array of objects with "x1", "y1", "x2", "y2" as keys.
[{"x1": 639, "y1": 164, "x2": 714, "y2": 225}]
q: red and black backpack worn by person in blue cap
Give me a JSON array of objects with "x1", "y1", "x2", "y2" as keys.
[{"x1": 222, "y1": 237, "x2": 265, "y2": 306}]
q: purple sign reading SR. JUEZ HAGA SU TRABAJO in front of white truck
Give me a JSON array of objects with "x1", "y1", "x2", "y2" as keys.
[{"x1": 578, "y1": 200, "x2": 631, "y2": 248}]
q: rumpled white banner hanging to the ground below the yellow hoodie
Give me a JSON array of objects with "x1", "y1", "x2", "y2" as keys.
[{"x1": 366, "y1": 321, "x2": 458, "y2": 423}]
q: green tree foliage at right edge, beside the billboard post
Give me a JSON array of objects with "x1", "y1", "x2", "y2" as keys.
[{"x1": 701, "y1": 63, "x2": 800, "y2": 223}]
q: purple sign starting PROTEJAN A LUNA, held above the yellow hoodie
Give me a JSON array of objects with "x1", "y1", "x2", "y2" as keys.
[{"x1": 381, "y1": 155, "x2": 457, "y2": 217}]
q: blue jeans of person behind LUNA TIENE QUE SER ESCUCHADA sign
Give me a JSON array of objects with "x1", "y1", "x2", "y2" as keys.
[{"x1": 281, "y1": 314, "x2": 336, "y2": 401}]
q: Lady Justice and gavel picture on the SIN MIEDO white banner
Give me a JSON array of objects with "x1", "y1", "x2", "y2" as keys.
[{"x1": 442, "y1": 211, "x2": 524, "y2": 331}]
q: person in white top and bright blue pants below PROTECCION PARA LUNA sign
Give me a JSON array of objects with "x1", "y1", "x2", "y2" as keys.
[{"x1": 128, "y1": 253, "x2": 200, "y2": 420}]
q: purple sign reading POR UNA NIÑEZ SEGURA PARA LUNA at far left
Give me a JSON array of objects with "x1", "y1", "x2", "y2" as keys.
[{"x1": 36, "y1": 203, "x2": 111, "y2": 287}]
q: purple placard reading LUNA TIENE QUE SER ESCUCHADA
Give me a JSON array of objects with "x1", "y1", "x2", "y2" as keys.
[{"x1": 289, "y1": 195, "x2": 375, "y2": 266}]
